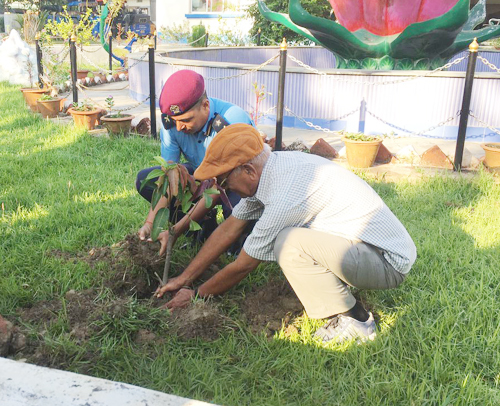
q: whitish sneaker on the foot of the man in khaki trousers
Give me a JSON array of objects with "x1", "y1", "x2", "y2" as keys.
[{"x1": 314, "y1": 313, "x2": 377, "y2": 343}]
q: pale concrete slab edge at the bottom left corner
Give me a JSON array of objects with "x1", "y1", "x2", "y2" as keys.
[{"x1": 0, "y1": 358, "x2": 219, "y2": 406}]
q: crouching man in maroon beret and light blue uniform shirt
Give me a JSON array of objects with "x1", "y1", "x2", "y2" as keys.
[{"x1": 136, "y1": 69, "x2": 254, "y2": 255}]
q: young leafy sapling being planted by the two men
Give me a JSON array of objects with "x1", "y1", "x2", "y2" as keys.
[{"x1": 141, "y1": 156, "x2": 231, "y2": 286}]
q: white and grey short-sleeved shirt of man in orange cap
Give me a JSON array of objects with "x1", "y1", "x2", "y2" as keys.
[{"x1": 232, "y1": 152, "x2": 417, "y2": 274}]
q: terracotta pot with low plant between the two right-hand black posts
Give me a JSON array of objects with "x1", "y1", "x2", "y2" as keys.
[{"x1": 342, "y1": 132, "x2": 382, "y2": 168}]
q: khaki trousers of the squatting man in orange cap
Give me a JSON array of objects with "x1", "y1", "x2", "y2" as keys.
[{"x1": 274, "y1": 227, "x2": 405, "y2": 319}]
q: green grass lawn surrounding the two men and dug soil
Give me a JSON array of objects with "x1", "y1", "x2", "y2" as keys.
[{"x1": 0, "y1": 84, "x2": 500, "y2": 405}]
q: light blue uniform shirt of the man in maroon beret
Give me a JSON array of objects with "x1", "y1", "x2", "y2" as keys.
[{"x1": 160, "y1": 97, "x2": 254, "y2": 169}]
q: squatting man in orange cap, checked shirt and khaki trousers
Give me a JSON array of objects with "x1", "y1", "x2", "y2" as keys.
[{"x1": 156, "y1": 124, "x2": 416, "y2": 342}]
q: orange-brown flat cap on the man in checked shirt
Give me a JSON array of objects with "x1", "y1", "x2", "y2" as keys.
[{"x1": 194, "y1": 124, "x2": 264, "y2": 180}]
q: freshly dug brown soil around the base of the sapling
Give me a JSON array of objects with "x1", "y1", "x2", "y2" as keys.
[{"x1": 6, "y1": 235, "x2": 303, "y2": 369}]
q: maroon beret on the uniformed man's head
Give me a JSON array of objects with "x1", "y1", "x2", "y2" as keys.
[{"x1": 160, "y1": 69, "x2": 205, "y2": 116}]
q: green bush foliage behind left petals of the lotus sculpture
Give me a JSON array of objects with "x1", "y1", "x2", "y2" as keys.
[{"x1": 247, "y1": 0, "x2": 332, "y2": 45}]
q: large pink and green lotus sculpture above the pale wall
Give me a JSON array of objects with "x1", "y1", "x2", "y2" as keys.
[{"x1": 258, "y1": 0, "x2": 500, "y2": 69}]
